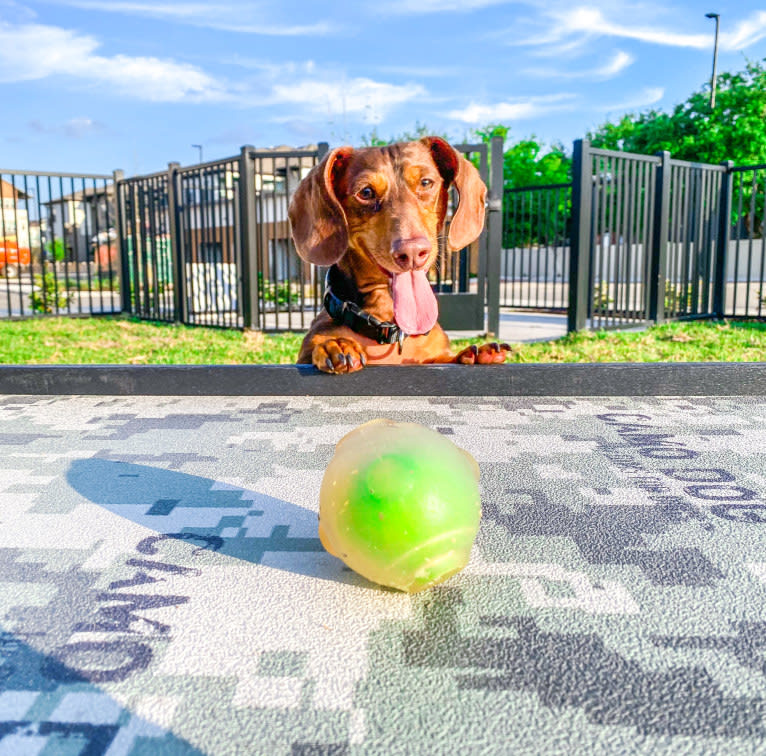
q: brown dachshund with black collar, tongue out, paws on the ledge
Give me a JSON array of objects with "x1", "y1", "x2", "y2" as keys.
[{"x1": 289, "y1": 137, "x2": 510, "y2": 373}]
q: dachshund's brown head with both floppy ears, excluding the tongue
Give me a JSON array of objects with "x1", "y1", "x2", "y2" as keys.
[{"x1": 289, "y1": 137, "x2": 487, "y2": 275}]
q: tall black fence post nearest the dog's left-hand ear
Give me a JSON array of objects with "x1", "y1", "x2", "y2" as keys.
[{"x1": 239, "y1": 144, "x2": 261, "y2": 330}]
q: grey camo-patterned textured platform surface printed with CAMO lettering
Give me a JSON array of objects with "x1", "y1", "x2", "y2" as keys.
[{"x1": 0, "y1": 396, "x2": 766, "y2": 756}]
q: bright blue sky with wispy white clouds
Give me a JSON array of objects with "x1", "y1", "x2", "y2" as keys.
[{"x1": 0, "y1": 0, "x2": 766, "y2": 175}]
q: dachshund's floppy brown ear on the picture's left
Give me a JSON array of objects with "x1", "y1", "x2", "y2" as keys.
[{"x1": 288, "y1": 147, "x2": 353, "y2": 265}]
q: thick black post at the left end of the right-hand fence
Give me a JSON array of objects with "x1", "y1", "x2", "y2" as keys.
[{"x1": 567, "y1": 139, "x2": 593, "y2": 332}]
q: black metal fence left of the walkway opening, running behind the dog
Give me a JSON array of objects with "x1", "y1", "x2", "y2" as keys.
[{"x1": 0, "y1": 139, "x2": 502, "y2": 332}]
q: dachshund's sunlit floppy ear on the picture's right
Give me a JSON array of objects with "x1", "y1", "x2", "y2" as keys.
[{"x1": 422, "y1": 137, "x2": 487, "y2": 250}]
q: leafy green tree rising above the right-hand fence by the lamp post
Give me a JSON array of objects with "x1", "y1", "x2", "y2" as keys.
[{"x1": 588, "y1": 59, "x2": 766, "y2": 165}]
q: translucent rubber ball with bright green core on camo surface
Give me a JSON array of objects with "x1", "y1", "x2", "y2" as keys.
[{"x1": 319, "y1": 420, "x2": 481, "y2": 593}]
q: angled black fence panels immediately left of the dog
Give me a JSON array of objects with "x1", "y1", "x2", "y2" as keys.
[{"x1": 117, "y1": 145, "x2": 326, "y2": 330}]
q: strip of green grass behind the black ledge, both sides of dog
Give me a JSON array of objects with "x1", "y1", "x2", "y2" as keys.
[{"x1": 0, "y1": 317, "x2": 766, "y2": 365}]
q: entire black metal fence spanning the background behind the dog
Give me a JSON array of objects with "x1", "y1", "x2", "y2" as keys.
[{"x1": 0, "y1": 139, "x2": 766, "y2": 332}]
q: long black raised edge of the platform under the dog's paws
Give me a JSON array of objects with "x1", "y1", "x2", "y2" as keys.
[{"x1": 0, "y1": 362, "x2": 766, "y2": 396}]
